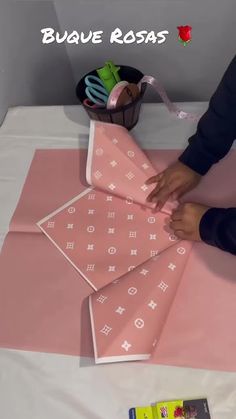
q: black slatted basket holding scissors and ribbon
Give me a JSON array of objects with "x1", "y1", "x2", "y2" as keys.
[{"x1": 76, "y1": 65, "x2": 146, "y2": 130}]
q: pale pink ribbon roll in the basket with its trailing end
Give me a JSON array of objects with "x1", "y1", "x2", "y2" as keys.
[{"x1": 107, "y1": 76, "x2": 200, "y2": 122}]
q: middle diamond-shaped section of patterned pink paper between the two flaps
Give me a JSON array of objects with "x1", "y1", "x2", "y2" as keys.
[{"x1": 39, "y1": 189, "x2": 176, "y2": 290}]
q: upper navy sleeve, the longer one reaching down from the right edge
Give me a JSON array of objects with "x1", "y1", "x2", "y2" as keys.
[{"x1": 179, "y1": 56, "x2": 236, "y2": 175}]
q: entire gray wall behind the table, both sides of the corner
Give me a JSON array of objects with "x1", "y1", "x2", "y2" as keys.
[{"x1": 0, "y1": 0, "x2": 236, "y2": 121}]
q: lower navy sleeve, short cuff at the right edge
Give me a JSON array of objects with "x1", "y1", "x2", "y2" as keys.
[{"x1": 200, "y1": 208, "x2": 236, "y2": 255}]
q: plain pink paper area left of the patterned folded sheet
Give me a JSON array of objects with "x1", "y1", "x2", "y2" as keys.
[{"x1": 0, "y1": 150, "x2": 93, "y2": 357}]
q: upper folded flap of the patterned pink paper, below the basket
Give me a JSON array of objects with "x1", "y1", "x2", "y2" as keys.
[{"x1": 86, "y1": 121, "x2": 177, "y2": 214}]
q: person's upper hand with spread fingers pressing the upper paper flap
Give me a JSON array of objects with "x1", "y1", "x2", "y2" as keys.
[{"x1": 146, "y1": 161, "x2": 201, "y2": 210}]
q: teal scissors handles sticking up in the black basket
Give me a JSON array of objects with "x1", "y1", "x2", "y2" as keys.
[{"x1": 84, "y1": 75, "x2": 108, "y2": 105}]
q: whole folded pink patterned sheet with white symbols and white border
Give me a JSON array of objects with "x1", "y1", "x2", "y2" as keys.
[{"x1": 37, "y1": 121, "x2": 191, "y2": 363}]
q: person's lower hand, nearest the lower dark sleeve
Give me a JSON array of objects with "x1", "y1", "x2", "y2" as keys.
[{"x1": 170, "y1": 203, "x2": 209, "y2": 241}]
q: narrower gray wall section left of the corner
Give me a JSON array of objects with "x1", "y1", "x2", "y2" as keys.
[{"x1": 0, "y1": 0, "x2": 76, "y2": 122}]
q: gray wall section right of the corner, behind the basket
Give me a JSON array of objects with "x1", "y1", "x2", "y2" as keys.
[{"x1": 54, "y1": 0, "x2": 236, "y2": 101}]
